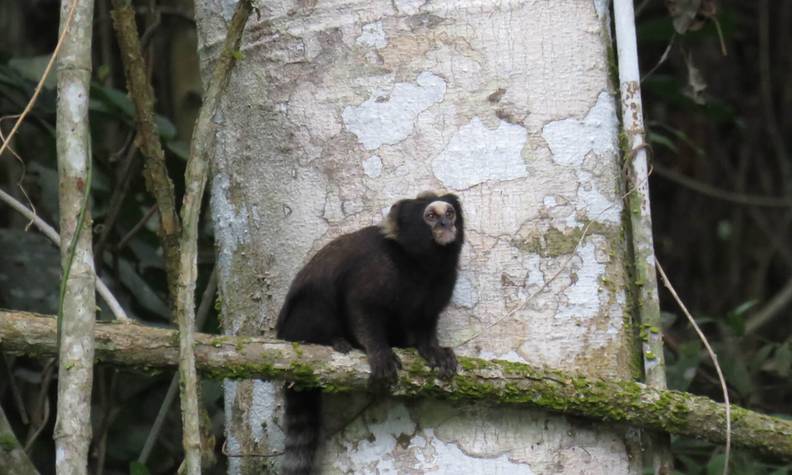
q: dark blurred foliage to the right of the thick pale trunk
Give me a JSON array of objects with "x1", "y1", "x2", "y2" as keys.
[{"x1": 636, "y1": 0, "x2": 792, "y2": 475}]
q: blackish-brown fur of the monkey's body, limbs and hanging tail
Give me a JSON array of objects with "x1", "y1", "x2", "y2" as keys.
[{"x1": 277, "y1": 193, "x2": 464, "y2": 474}]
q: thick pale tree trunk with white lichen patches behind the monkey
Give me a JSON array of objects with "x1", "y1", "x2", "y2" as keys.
[{"x1": 196, "y1": 0, "x2": 640, "y2": 474}]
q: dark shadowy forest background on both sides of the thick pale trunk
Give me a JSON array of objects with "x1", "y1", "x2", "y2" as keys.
[{"x1": 0, "y1": 0, "x2": 792, "y2": 475}]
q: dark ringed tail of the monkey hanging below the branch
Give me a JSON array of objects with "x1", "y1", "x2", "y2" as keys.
[{"x1": 281, "y1": 389, "x2": 322, "y2": 475}]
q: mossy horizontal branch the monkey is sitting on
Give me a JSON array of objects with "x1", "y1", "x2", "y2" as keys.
[{"x1": 0, "y1": 311, "x2": 792, "y2": 461}]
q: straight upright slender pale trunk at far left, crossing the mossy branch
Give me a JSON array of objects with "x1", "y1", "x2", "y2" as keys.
[{"x1": 54, "y1": 0, "x2": 96, "y2": 474}]
